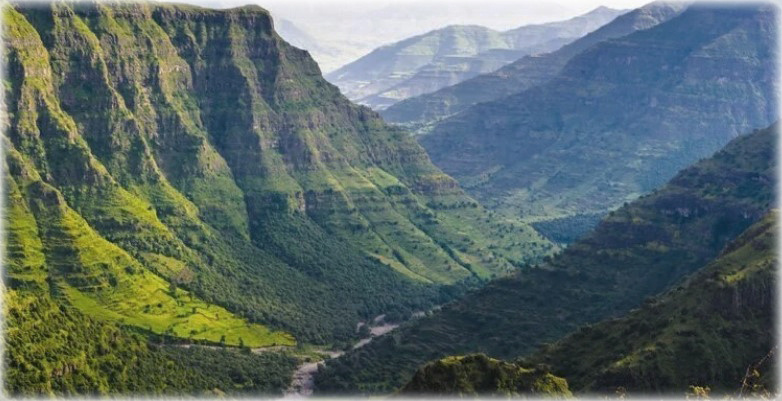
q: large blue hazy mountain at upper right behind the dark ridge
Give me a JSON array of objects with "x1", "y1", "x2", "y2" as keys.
[{"x1": 420, "y1": 4, "x2": 778, "y2": 228}]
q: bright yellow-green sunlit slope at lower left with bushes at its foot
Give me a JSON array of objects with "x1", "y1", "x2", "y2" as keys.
[{"x1": 3, "y1": 153, "x2": 296, "y2": 396}]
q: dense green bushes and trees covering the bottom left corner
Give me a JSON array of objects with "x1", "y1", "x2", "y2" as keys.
[{"x1": 4, "y1": 290, "x2": 296, "y2": 396}]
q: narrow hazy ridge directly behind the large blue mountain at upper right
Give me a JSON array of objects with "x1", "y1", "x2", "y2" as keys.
[{"x1": 380, "y1": 2, "x2": 686, "y2": 129}]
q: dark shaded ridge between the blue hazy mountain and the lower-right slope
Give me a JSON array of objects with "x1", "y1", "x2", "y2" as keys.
[{"x1": 316, "y1": 126, "x2": 778, "y2": 393}]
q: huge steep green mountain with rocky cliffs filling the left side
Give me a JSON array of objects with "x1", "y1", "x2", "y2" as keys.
[{"x1": 3, "y1": 2, "x2": 553, "y2": 393}]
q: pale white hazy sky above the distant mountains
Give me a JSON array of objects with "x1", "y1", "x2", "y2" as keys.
[{"x1": 169, "y1": 0, "x2": 651, "y2": 72}]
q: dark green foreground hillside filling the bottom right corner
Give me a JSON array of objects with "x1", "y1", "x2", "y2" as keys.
[{"x1": 401, "y1": 211, "x2": 778, "y2": 398}]
